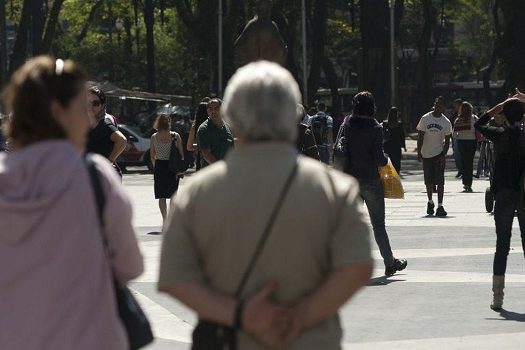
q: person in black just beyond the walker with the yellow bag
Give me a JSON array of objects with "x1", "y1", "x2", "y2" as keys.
[{"x1": 383, "y1": 107, "x2": 407, "y2": 174}]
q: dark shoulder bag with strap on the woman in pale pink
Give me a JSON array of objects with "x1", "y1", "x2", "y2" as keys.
[{"x1": 85, "y1": 156, "x2": 155, "y2": 350}]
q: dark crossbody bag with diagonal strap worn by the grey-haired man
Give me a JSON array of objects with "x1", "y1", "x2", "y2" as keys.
[{"x1": 191, "y1": 163, "x2": 298, "y2": 350}]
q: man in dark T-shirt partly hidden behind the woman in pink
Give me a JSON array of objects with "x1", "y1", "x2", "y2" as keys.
[{"x1": 87, "y1": 86, "x2": 128, "y2": 176}]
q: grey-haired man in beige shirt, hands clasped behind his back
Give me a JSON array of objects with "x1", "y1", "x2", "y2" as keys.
[{"x1": 158, "y1": 61, "x2": 373, "y2": 350}]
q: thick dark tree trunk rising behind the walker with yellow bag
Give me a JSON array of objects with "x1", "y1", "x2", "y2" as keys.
[{"x1": 359, "y1": 0, "x2": 390, "y2": 113}]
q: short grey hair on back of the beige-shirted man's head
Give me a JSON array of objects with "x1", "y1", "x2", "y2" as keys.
[{"x1": 221, "y1": 61, "x2": 301, "y2": 142}]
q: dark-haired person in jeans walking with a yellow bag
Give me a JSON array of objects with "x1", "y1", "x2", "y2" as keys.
[{"x1": 344, "y1": 91, "x2": 407, "y2": 276}]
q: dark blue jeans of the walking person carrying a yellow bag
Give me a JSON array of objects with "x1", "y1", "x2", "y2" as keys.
[{"x1": 358, "y1": 179, "x2": 394, "y2": 266}]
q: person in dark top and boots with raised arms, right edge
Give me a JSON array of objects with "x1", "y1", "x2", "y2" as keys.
[{"x1": 475, "y1": 93, "x2": 525, "y2": 310}]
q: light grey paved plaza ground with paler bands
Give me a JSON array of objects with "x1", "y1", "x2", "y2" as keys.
[{"x1": 124, "y1": 145, "x2": 525, "y2": 350}]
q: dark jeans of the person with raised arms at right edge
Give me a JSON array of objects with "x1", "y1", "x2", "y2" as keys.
[{"x1": 493, "y1": 188, "x2": 525, "y2": 276}]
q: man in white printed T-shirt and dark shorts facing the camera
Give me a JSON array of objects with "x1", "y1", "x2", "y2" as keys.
[{"x1": 417, "y1": 96, "x2": 452, "y2": 217}]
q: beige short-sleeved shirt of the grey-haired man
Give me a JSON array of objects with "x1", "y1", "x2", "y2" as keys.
[{"x1": 159, "y1": 143, "x2": 372, "y2": 350}]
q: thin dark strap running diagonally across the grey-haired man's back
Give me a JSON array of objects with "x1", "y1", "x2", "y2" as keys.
[{"x1": 235, "y1": 161, "x2": 299, "y2": 299}]
